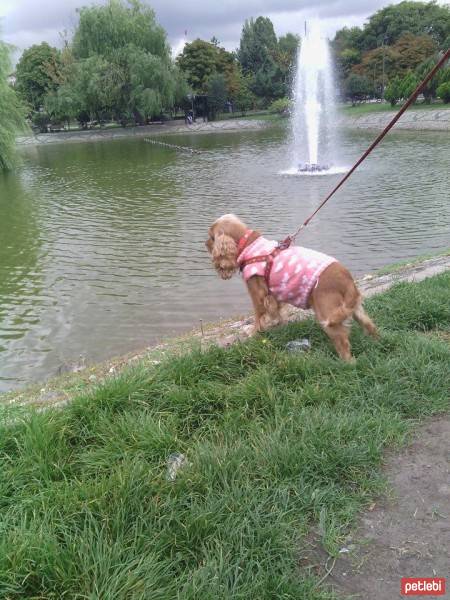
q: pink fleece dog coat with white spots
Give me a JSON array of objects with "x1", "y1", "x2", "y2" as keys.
[{"x1": 238, "y1": 237, "x2": 337, "y2": 309}]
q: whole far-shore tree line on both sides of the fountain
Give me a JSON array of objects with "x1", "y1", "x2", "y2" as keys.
[{"x1": 8, "y1": 0, "x2": 450, "y2": 128}]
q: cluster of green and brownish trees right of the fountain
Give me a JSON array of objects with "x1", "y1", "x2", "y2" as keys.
[{"x1": 332, "y1": 1, "x2": 450, "y2": 105}]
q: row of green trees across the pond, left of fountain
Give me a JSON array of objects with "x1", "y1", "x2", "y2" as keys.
[{"x1": 15, "y1": 0, "x2": 299, "y2": 130}]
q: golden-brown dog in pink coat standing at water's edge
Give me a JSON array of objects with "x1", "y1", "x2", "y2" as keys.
[{"x1": 206, "y1": 215, "x2": 378, "y2": 361}]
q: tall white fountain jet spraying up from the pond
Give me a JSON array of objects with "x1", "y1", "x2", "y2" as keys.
[{"x1": 292, "y1": 21, "x2": 336, "y2": 172}]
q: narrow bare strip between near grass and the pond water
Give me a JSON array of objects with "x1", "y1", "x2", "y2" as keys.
[{"x1": 0, "y1": 251, "x2": 450, "y2": 409}]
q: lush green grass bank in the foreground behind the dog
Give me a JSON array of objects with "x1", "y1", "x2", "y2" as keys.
[{"x1": 0, "y1": 273, "x2": 450, "y2": 600}]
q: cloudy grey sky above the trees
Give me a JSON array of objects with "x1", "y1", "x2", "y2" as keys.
[{"x1": 0, "y1": 0, "x2": 445, "y2": 61}]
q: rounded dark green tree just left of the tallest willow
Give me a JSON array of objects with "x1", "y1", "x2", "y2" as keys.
[{"x1": 16, "y1": 42, "x2": 60, "y2": 110}]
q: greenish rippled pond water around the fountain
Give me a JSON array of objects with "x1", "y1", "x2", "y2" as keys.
[{"x1": 0, "y1": 127, "x2": 450, "y2": 391}]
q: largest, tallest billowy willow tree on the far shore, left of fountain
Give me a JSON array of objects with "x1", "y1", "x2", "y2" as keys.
[{"x1": 67, "y1": 0, "x2": 186, "y2": 124}]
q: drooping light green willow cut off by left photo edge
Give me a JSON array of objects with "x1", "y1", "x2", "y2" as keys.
[{"x1": 0, "y1": 40, "x2": 25, "y2": 171}]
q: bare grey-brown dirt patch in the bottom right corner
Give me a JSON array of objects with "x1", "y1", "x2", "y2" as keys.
[{"x1": 302, "y1": 417, "x2": 450, "y2": 600}]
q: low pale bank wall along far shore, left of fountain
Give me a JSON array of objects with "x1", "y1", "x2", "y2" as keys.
[{"x1": 17, "y1": 119, "x2": 269, "y2": 146}]
